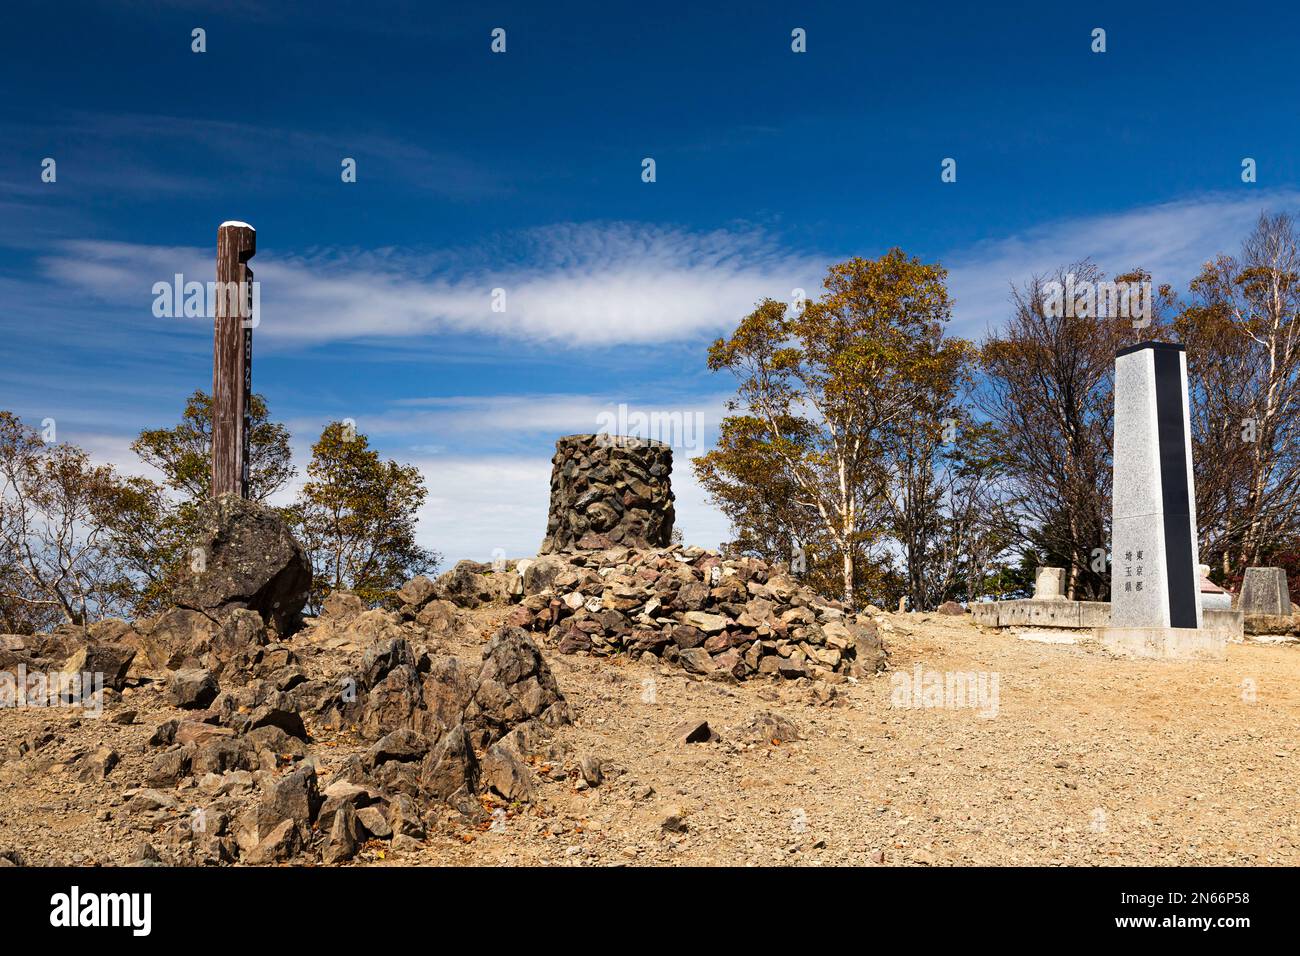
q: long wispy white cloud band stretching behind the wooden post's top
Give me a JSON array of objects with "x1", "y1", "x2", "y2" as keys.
[{"x1": 43, "y1": 224, "x2": 823, "y2": 347}]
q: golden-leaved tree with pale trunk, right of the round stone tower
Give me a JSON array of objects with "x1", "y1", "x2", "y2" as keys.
[{"x1": 694, "y1": 250, "x2": 965, "y2": 606}]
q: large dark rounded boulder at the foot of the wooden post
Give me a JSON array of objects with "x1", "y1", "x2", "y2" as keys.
[{"x1": 177, "y1": 494, "x2": 312, "y2": 633}]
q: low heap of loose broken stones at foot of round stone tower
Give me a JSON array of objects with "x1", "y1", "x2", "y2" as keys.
[{"x1": 403, "y1": 545, "x2": 888, "y2": 680}]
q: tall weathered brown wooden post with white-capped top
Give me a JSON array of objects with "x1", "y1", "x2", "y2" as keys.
[{"x1": 212, "y1": 222, "x2": 257, "y2": 498}]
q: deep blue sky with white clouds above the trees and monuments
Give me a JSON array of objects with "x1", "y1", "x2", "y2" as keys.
[{"x1": 0, "y1": 0, "x2": 1300, "y2": 559}]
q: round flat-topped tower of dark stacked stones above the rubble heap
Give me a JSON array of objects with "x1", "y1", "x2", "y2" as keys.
[{"x1": 541, "y1": 434, "x2": 675, "y2": 554}]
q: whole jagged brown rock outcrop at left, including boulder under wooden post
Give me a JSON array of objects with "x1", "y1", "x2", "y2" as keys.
[{"x1": 0, "y1": 499, "x2": 569, "y2": 865}]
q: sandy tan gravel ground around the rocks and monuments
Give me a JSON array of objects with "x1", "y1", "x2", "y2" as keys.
[{"x1": 0, "y1": 606, "x2": 1300, "y2": 866}]
